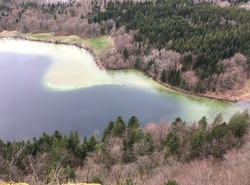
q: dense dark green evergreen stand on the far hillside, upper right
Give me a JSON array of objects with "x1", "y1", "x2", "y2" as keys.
[{"x1": 91, "y1": 1, "x2": 250, "y2": 63}]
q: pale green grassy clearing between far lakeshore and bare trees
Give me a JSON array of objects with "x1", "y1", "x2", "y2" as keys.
[{"x1": 0, "y1": 31, "x2": 113, "y2": 54}]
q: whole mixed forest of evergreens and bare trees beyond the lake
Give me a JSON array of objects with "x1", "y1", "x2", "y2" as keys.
[{"x1": 0, "y1": 0, "x2": 250, "y2": 93}]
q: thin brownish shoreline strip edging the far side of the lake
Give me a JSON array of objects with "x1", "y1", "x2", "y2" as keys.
[{"x1": 0, "y1": 31, "x2": 249, "y2": 102}]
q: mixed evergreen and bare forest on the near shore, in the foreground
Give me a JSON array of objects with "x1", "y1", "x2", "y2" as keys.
[{"x1": 0, "y1": 111, "x2": 250, "y2": 185}]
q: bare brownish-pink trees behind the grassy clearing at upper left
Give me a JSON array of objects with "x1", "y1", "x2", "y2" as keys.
[{"x1": 0, "y1": 0, "x2": 106, "y2": 37}]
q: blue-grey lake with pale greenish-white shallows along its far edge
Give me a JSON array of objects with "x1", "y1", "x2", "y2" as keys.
[{"x1": 0, "y1": 39, "x2": 250, "y2": 141}]
